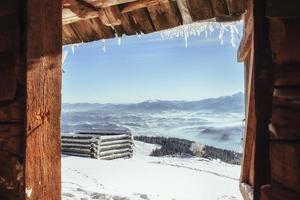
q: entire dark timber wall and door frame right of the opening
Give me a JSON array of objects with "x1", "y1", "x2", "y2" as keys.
[{"x1": 238, "y1": 0, "x2": 300, "y2": 200}]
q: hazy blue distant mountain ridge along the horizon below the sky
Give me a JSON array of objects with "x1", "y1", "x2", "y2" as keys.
[{"x1": 62, "y1": 92, "x2": 245, "y2": 112}]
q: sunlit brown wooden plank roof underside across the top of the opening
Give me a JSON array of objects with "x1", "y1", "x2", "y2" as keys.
[{"x1": 63, "y1": 0, "x2": 245, "y2": 44}]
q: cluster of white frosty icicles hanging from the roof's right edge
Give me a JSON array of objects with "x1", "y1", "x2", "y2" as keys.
[{"x1": 160, "y1": 22, "x2": 239, "y2": 48}]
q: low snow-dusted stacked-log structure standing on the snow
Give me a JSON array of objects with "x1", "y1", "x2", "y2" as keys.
[{"x1": 61, "y1": 130, "x2": 133, "y2": 160}]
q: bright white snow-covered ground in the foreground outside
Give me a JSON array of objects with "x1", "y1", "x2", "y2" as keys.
[{"x1": 62, "y1": 141, "x2": 242, "y2": 200}]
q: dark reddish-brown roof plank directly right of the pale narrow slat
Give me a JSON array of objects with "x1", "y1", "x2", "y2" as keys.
[{"x1": 187, "y1": 0, "x2": 215, "y2": 21}]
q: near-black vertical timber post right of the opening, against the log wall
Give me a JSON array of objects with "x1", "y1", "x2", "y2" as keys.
[{"x1": 252, "y1": 0, "x2": 274, "y2": 200}]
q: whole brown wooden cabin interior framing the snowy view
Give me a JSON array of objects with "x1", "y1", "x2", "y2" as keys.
[{"x1": 0, "y1": 0, "x2": 300, "y2": 200}]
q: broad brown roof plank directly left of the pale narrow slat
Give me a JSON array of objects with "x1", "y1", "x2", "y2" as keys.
[{"x1": 147, "y1": 2, "x2": 182, "y2": 31}]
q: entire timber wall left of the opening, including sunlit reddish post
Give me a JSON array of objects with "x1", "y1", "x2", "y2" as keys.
[{"x1": 0, "y1": 0, "x2": 62, "y2": 200}]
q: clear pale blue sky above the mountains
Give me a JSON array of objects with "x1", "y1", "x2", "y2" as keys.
[{"x1": 62, "y1": 25, "x2": 244, "y2": 103}]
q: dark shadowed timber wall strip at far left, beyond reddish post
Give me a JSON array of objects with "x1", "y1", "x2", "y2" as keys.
[{"x1": 0, "y1": 0, "x2": 25, "y2": 200}]
